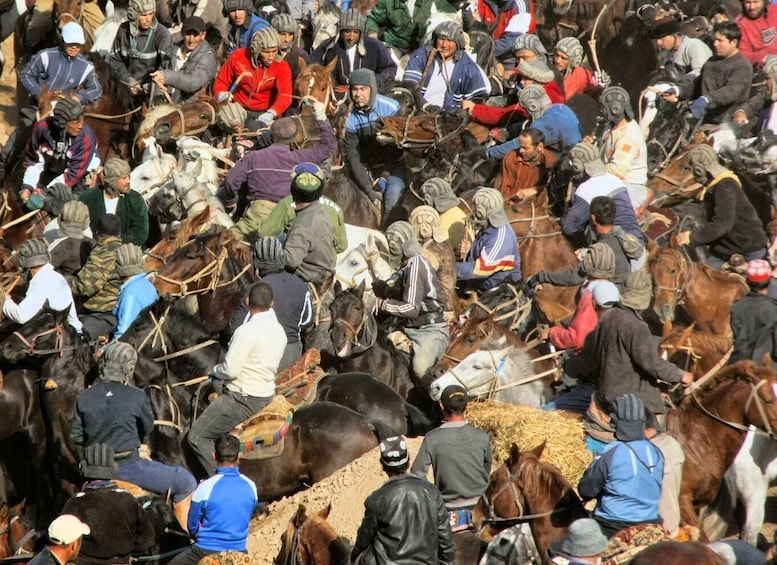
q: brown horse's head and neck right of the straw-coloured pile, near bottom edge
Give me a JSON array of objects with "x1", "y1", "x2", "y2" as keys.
[{"x1": 472, "y1": 442, "x2": 587, "y2": 561}]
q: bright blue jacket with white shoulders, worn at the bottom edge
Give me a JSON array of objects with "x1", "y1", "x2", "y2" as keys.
[{"x1": 187, "y1": 467, "x2": 258, "y2": 551}]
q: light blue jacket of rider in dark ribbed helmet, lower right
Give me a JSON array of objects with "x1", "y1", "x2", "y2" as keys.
[{"x1": 577, "y1": 439, "x2": 664, "y2": 524}]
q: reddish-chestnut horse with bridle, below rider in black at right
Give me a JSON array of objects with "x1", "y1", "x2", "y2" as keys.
[{"x1": 649, "y1": 248, "x2": 747, "y2": 336}]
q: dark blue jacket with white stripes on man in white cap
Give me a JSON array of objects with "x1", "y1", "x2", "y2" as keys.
[{"x1": 19, "y1": 47, "x2": 103, "y2": 106}]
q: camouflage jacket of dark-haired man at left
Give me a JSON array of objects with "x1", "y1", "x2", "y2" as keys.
[{"x1": 69, "y1": 235, "x2": 122, "y2": 312}]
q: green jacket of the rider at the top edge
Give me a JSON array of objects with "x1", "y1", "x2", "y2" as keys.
[{"x1": 366, "y1": 0, "x2": 456, "y2": 52}]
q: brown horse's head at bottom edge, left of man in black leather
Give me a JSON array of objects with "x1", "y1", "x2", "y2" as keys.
[{"x1": 274, "y1": 504, "x2": 351, "y2": 565}]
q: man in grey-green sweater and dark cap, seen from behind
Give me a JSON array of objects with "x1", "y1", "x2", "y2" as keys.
[{"x1": 410, "y1": 385, "x2": 491, "y2": 532}]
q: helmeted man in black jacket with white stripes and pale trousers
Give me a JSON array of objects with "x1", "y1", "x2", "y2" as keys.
[{"x1": 372, "y1": 221, "x2": 450, "y2": 379}]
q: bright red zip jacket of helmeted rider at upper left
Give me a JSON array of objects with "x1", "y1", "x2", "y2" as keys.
[{"x1": 213, "y1": 47, "x2": 292, "y2": 117}]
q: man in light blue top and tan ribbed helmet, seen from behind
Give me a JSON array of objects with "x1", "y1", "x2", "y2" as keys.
[{"x1": 113, "y1": 243, "x2": 159, "y2": 339}]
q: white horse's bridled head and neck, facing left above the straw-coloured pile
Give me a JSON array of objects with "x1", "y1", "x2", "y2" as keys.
[{"x1": 429, "y1": 336, "x2": 548, "y2": 408}]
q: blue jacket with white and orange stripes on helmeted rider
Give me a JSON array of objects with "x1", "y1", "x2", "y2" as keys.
[{"x1": 456, "y1": 224, "x2": 521, "y2": 290}]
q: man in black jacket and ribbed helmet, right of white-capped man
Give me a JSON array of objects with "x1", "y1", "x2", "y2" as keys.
[{"x1": 108, "y1": 0, "x2": 175, "y2": 101}]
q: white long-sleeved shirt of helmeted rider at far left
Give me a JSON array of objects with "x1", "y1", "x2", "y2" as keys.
[{"x1": 3, "y1": 263, "x2": 83, "y2": 333}]
